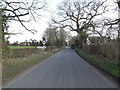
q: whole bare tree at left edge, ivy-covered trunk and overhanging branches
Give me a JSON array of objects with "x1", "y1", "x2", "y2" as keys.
[{"x1": 0, "y1": 0, "x2": 46, "y2": 57}]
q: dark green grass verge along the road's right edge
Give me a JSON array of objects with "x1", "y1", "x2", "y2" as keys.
[{"x1": 75, "y1": 49, "x2": 120, "y2": 79}]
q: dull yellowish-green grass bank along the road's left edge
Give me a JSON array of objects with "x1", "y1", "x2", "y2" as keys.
[{"x1": 2, "y1": 49, "x2": 60, "y2": 85}]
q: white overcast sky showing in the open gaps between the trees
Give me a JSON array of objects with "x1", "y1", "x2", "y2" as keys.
[{"x1": 9, "y1": 0, "x2": 118, "y2": 43}]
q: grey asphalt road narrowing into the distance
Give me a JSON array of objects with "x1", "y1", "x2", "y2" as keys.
[{"x1": 4, "y1": 48, "x2": 117, "y2": 88}]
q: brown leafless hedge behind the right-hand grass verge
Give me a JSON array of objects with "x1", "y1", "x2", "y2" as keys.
[{"x1": 83, "y1": 41, "x2": 118, "y2": 60}]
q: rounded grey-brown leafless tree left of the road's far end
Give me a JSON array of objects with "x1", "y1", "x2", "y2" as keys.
[{"x1": 43, "y1": 25, "x2": 69, "y2": 47}]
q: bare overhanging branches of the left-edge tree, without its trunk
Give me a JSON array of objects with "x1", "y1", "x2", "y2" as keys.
[{"x1": 0, "y1": 0, "x2": 46, "y2": 33}]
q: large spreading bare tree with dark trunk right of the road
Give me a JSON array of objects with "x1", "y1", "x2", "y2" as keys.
[{"x1": 53, "y1": 0, "x2": 107, "y2": 47}]
